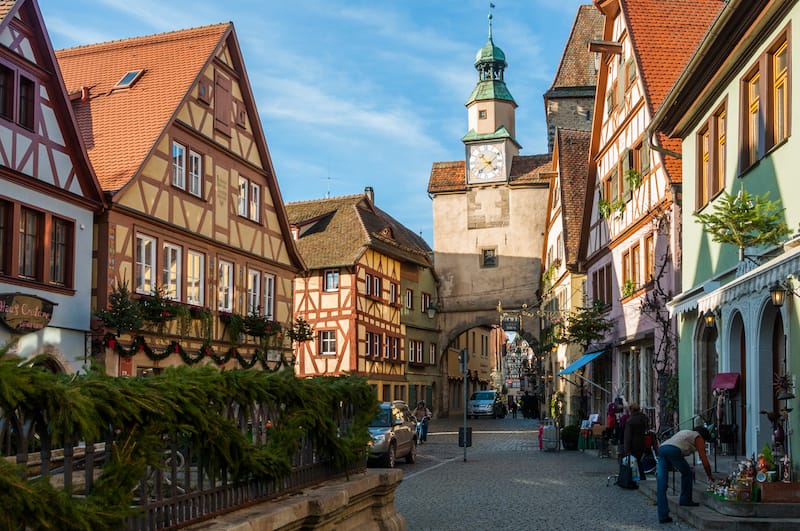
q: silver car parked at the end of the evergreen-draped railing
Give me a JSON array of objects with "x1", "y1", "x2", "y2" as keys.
[{"x1": 367, "y1": 400, "x2": 417, "y2": 468}]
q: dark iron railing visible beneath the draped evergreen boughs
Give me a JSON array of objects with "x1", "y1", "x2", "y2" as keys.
[{"x1": 0, "y1": 404, "x2": 366, "y2": 530}]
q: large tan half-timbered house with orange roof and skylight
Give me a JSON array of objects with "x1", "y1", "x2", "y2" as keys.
[{"x1": 57, "y1": 23, "x2": 303, "y2": 375}]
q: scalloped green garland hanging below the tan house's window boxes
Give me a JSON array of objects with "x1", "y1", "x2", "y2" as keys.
[{"x1": 104, "y1": 332, "x2": 290, "y2": 372}]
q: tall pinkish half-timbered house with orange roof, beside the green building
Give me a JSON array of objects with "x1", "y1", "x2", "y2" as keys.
[{"x1": 582, "y1": 0, "x2": 723, "y2": 424}]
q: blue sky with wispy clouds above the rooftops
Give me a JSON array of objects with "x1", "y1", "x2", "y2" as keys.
[{"x1": 39, "y1": 0, "x2": 591, "y2": 247}]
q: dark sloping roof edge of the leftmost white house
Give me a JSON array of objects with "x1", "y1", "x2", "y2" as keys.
[{"x1": 0, "y1": 0, "x2": 106, "y2": 211}]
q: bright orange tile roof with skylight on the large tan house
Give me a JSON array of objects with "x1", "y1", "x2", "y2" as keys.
[{"x1": 56, "y1": 23, "x2": 232, "y2": 192}]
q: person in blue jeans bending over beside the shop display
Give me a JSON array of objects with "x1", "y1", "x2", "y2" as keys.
[{"x1": 656, "y1": 427, "x2": 714, "y2": 524}]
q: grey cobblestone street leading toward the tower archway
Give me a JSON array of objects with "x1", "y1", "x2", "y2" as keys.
[{"x1": 395, "y1": 417, "x2": 692, "y2": 531}]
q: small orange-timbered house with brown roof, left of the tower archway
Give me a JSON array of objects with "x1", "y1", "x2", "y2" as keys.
[{"x1": 286, "y1": 189, "x2": 436, "y2": 401}]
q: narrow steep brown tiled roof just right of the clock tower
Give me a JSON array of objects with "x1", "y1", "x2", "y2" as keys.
[{"x1": 556, "y1": 129, "x2": 592, "y2": 268}]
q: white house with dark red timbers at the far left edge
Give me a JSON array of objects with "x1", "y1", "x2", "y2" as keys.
[{"x1": 0, "y1": 0, "x2": 103, "y2": 372}]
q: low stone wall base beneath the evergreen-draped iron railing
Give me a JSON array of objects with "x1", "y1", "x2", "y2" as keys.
[{"x1": 186, "y1": 468, "x2": 406, "y2": 531}]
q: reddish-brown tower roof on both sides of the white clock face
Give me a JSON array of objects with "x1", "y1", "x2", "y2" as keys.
[{"x1": 428, "y1": 153, "x2": 553, "y2": 194}]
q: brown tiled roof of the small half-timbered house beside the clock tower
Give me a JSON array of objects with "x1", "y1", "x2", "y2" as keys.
[{"x1": 286, "y1": 194, "x2": 431, "y2": 269}]
